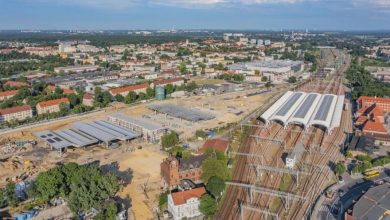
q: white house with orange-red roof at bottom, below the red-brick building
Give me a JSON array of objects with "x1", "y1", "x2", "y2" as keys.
[{"x1": 168, "y1": 187, "x2": 206, "y2": 220}]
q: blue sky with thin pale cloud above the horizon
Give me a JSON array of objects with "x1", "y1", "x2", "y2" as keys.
[{"x1": 0, "y1": 0, "x2": 390, "y2": 30}]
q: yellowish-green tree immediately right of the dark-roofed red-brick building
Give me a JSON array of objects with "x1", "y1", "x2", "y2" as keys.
[{"x1": 201, "y1": 157, "x2": 229, "y2": 183}]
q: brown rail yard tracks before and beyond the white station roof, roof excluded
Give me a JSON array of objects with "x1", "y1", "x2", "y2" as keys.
[{"x1": 217, "y1": 49, "x2": 352, "y2": 219}]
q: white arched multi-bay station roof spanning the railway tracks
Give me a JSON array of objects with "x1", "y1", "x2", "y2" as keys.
[{"x1": 261, "y1": 91, "x2": 344, "y2": 132}]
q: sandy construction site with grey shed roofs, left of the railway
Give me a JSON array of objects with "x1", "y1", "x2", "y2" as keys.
[{"x1": 0, "y1": 86, "x2": 283, "y2": 219}]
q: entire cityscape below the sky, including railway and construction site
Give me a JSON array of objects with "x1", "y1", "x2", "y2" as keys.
[{"x1": 0, "y1": 30, "x2": 390, "y2": 220}]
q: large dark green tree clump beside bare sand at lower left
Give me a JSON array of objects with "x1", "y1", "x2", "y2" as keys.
[{"x1": 29, "y1": 163, "x2": 119, "y2": 213}]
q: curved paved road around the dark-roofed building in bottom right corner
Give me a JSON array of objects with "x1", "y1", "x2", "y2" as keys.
[{"x1": 316, "y1": 169, "x2": 390, "y2": 220}]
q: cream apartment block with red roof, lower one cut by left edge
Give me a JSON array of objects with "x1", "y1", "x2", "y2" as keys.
[{"x1": 0, "y1": 105, "x2": 33, "y2": 123}]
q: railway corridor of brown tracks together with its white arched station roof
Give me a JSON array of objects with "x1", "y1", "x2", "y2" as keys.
[{"x1": 217, "y1": 49, "x2": 352, "y2": 219}]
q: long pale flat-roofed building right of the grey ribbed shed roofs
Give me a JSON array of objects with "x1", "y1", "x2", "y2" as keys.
[{"x1": 108, "y1": 113, "x2": 168, "y2": 142}]
